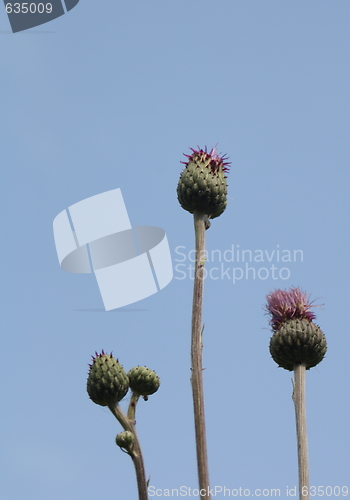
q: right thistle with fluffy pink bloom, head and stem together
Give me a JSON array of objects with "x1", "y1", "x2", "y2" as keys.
[{"x1": 265, "y1": 288, "x2": 327, "y2": 500}]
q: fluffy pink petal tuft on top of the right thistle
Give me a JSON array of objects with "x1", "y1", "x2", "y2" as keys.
[{"x1": 265, "y1": 287, "x2": 317, "y2": 330}]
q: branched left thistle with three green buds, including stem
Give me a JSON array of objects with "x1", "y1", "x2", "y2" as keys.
[{"x1": 86, "y1": 351, "x2": 160, "y2": 500}]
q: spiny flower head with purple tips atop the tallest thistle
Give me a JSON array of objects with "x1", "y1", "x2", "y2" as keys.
[{"x1": 177, "y1": 148, "x2": 229, "y2": 219}]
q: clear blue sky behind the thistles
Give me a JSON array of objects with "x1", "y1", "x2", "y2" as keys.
[{"x1": 0, "y1": 0, "x2": 350, "y2": 500}]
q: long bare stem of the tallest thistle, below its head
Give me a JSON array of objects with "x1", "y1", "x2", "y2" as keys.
[{"x1": 191, "y1": 213, "x2": 210, "y2": 500}]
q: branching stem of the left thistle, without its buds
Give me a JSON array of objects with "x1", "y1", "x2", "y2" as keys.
[{"x1": 108, "y1": 401, "x2": 148, "y2": 500}]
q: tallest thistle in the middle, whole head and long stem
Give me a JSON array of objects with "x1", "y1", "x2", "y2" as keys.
[{"x1": 177, "y1": 148, "x2": 229, "y2": 500}]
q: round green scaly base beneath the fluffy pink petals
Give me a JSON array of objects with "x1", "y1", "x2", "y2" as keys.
[{"x1": 270, "y1": 319, "x2": 327, "y2": 371}]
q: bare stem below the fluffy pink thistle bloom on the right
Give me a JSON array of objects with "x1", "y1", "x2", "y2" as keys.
[{"x1": 293, "y1": 364, "x2": 309, "y2": 500}]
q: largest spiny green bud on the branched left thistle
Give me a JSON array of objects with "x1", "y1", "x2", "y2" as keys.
[{"x1": 87, "y1": 351, "x2": 129, "y2": 406}]
